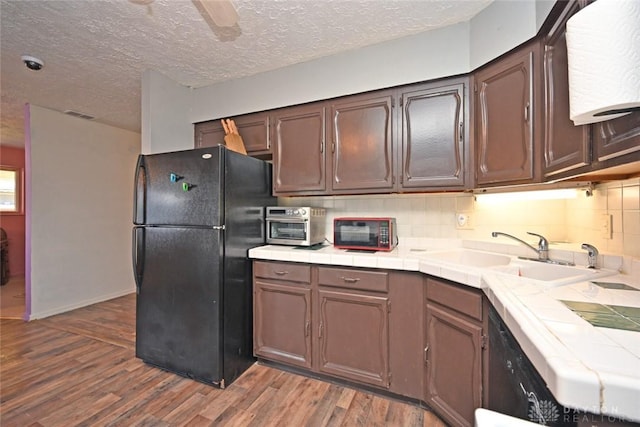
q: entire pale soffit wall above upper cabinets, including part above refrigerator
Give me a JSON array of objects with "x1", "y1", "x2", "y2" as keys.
[{"x1": 142, "y1": 0, "x2": 553, "y2": 153}]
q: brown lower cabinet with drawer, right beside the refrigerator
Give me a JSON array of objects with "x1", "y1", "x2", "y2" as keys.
[{"x1": 253, "y1": 261, "x2": 312, "y2": 368}]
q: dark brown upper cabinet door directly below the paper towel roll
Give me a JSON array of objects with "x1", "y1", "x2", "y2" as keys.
[{"x1": 593, "y1": 111, "x2": 640, "y2": 161}]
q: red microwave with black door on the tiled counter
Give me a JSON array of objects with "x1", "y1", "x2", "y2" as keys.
[{"x1": 333, "y1": 217, "x2": 398, "y2": 251}]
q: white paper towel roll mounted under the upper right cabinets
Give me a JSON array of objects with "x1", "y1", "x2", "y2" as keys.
[{"x1": 566, "y1": 0, "x2": 640, "y2": 126}]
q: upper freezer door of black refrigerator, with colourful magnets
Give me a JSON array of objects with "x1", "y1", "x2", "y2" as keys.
[{"x1": 134, "y1": 147, "x2": 224, "y2": 226}]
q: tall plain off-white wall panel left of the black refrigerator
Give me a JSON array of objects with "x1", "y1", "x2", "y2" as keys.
[{"x1": 26, "y1": 106, "x2": 140, "y2": 319}]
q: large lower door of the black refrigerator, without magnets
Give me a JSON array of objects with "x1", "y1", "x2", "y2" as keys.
[{"x1": 134, "y1": 227, "x2": 223, "y2": 384}]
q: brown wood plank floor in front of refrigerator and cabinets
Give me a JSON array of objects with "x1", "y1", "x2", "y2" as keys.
[{"x1": 0, "y1": 295, "x2": 444, "y2": 427}]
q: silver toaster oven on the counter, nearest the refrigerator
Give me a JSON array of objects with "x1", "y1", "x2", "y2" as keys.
[{"x1": 265, "y1": 206, "x2": 326, "y2": 246}]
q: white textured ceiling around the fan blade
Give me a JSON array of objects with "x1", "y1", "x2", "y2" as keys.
[{"x1": 0, "y1": 0, "x2": 492, "y2": 146}]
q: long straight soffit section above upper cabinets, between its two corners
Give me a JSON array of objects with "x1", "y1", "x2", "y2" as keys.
[{"x1": 192, "y1": 23, "x2": 469, "y2": 122}]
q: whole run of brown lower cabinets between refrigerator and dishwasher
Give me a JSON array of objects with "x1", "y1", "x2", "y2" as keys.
[{"x1": 253, "y1": 260, "x2": 487, "y2": 426}]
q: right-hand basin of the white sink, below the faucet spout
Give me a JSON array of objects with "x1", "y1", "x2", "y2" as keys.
[{"x1": 491, "y1": 260, "x2": 615, "y2": 287}]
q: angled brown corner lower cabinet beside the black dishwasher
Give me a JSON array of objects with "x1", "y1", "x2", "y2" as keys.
[{"x1": 424, "y1": 278, "x2": 486, "y2": 426}]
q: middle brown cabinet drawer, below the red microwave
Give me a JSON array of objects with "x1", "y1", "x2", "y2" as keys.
[{"x1": 318, "y1": 267, "x2": 389, "y2": 292}]
